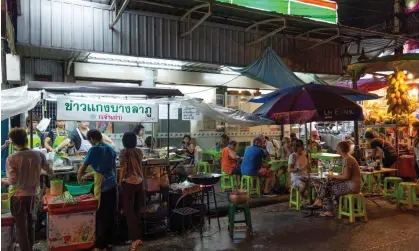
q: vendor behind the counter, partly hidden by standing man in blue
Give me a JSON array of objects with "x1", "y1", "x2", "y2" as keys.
[{"x1": 55, "y1": 121, "x2": 115, "y2": 153}]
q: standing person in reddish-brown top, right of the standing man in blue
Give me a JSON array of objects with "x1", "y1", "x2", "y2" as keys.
[{"x1": 118, "y1": 132, "x2": 145, "y2": 251}]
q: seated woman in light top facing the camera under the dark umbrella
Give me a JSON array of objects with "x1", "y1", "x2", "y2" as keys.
[{"x1": 288, "y1": 139, "x2": 309, "y2": 202}]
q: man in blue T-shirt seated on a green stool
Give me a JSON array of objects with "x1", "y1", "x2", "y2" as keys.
[{"x1": 241, "y1": 137, "x2": 276, "y2": 197}]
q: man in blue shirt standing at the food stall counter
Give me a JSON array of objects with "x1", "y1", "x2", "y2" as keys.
[{"x1": 77, "y1": 129, "x2": 117, "y2": 250}]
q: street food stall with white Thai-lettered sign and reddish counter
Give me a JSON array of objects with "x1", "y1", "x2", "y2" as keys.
[{"x1": 23, "y1": 82, "x2": 187, "y2": 250}]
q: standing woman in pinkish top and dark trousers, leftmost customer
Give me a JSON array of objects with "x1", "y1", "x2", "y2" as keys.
[{"x1": 2, "y1": 128, "x2": 53, "y2": 251}]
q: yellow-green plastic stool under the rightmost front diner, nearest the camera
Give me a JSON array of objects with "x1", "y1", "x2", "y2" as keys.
[{"x1": 338, "y1": 193, "x2": 368, "y2": 222}]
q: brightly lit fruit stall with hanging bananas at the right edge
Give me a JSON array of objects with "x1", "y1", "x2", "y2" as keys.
[{"x1": 348, "y1": 54, "x2": 419, "y2": 178}]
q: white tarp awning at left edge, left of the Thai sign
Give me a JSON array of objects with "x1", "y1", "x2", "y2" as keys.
[{"x1": 1, "y1": 86, "x2": 41, "y2": 120}]
